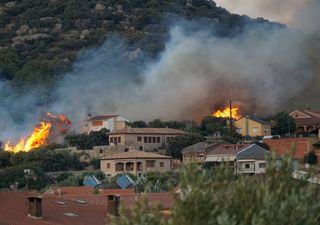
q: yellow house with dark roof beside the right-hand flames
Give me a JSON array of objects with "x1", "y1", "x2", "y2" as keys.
[{"x1": 234, "y1": 115, "x2": 271, "y2": 137}]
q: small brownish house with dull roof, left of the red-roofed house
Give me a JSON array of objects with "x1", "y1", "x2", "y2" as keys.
[{"x1": 181, "y1": 140, "x2": 223, "y2": 164}]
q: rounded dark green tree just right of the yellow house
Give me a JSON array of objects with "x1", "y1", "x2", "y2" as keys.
[{"x1": 272, "y1": 112, "x2": 296, "y2": 136}]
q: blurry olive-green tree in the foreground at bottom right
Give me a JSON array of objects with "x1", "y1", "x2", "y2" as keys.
[{"x1": 113, "y1": 159, "x2": 320, "y2": 225}]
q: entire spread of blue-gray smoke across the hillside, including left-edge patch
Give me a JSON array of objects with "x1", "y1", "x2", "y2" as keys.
[{"x1": 0, "y1": 0, "x2": 320, "y2": 140}]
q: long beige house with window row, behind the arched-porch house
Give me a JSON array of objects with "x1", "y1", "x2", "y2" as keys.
[{"x1": 109, "y1": 126, "x2": 188, "y2": 151}]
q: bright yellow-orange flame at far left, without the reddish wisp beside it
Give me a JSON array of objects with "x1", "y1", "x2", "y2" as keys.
[{"x1": 4, "y1": 122, "x2": 52, "y2": 153}]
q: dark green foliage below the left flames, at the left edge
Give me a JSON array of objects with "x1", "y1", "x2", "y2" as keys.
[{"x1": 0, "y1": 149, "x2": 87, "y2": 189}]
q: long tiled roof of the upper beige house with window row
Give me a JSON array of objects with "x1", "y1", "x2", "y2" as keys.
[{"x1": 109, "y1": 127, "x2": 187, "y2": 135}]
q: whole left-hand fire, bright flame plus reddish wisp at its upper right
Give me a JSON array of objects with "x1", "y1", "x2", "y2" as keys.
[{"x1": 4, "y1": 112, "x2": 71, "y2": 153}]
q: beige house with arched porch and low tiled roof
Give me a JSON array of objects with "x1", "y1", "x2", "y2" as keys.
[{"x1": 100, "y1": 150, "x2": 172, "y2": 176}]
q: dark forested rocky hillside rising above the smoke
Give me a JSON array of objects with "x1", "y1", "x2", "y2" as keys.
[{"x1": 0, "y1": 0, "x2": 276, "y2": 86}]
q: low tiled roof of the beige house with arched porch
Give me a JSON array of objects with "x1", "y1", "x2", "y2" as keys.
[{"x1": 101, "y1": 150, "x2": 171, "y2": 160}]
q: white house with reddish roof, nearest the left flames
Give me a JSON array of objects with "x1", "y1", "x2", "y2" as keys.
[{"x1": 80, "y1": 115, "x2": 129, "y2": 133}]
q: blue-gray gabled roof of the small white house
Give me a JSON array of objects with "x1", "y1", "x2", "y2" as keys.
[{"x1": 237, "y1": 144, "x2": 270, "y2": 160}]
